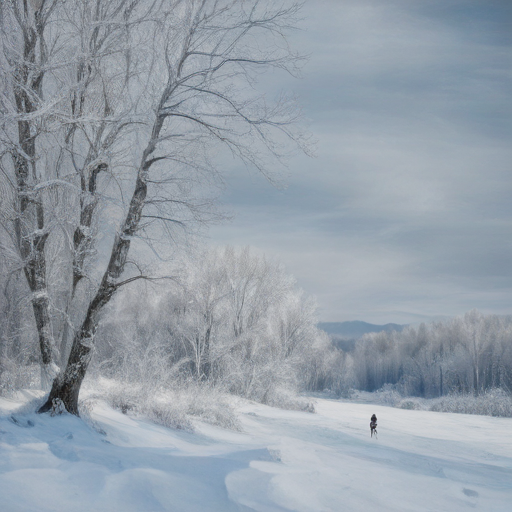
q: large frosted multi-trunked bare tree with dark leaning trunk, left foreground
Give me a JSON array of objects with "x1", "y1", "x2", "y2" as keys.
[{"x1": 2, "y1": 0, "x2": 305, "y2": 414}]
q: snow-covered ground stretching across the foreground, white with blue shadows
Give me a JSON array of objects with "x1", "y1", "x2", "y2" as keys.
[{"x1": 0, "y1": 392, "x2": 512, "y2": 512}]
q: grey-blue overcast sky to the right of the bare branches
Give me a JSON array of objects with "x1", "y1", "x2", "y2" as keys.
[{"x1": 211, "y1": 0, "x2": 512, "y2": 323}]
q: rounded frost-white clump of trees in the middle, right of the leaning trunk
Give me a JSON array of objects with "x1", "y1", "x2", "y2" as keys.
[{"x1": 94, "y1": 247, "x2": 324, "y2": 405}]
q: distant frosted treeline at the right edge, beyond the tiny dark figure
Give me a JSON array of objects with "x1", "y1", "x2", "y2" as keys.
[{"x1": 347, "y1": 310, "x2": 512, "y2": 398}]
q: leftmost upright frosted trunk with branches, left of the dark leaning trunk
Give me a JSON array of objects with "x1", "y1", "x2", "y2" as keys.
[{"x1": 0, "y1": 0, "x2": 63, "y2": 382}]
